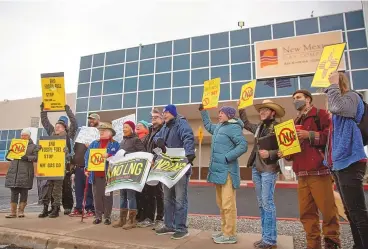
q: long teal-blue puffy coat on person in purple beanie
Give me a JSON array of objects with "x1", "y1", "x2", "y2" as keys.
[{"x1": 201, "y1": 111, "x2": 248, "y2": 188}]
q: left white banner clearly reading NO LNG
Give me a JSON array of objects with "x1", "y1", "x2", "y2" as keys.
[{"x1": 105, "y1": 151, "x2": 153, "y2": 194}]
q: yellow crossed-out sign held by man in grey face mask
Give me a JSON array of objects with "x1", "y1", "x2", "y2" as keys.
[{"x1": 274, "y1": 119, "x2": 301, "y2": 156}]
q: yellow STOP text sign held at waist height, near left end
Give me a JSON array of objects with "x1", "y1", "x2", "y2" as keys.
[{"x1": 36, "y1": 137, "x2": 66, "y2": 179}]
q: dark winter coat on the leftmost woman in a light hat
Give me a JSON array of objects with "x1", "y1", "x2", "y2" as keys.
[{"x1": 5, "y1": 139, "x2": 39, "y2": 189}]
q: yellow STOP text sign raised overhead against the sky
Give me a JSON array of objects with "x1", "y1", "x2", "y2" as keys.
[{"x1": 41, "y1": 73, "x2": 65, "y2": 111}]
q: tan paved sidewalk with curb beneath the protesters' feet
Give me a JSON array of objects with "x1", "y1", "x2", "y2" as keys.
[{"x1": 0, "y1": 214, "x2": 294, "y2": 249}]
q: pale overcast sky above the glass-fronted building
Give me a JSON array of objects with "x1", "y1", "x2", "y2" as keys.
[{"x1": 0, "y1": 0, "x2": 361, "y2": 101}]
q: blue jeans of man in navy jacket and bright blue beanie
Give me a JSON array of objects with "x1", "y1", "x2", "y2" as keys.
[{"x1": 164, "y1": 169, "x2": 192, "y2": 232}]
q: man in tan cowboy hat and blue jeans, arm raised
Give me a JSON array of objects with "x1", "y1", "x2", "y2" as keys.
[{"x1": 239, "y1": 99, "x2": 285, "y2": 249}]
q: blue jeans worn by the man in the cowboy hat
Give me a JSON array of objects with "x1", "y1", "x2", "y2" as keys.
[{"x1": 252, "y1": 167, "x2": 277, "y2": 245}]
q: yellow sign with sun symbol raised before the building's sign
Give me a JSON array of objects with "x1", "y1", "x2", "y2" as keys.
[{"x1": 312, "y1": 42, "x2": 346, "y2": 87}]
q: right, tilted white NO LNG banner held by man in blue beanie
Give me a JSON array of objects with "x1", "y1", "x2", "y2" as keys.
[{"x1": 147, "y1": 148, "x2": 190, "y2": 188}]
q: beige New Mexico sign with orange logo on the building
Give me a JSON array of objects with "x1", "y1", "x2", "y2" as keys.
[{"x1": 254, "y1": 31, "x2": 345, "y2": 79}]
